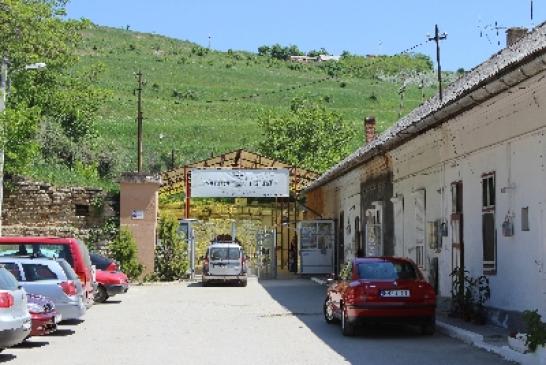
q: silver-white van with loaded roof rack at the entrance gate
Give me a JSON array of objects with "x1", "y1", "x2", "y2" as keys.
[{"x1": 203, "y1": 242, "x2": 247, "y2": 286}]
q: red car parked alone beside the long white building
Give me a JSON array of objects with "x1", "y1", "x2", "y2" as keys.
[{"x1": 324, "y1": 257, "x2": 436, "y2": 336}]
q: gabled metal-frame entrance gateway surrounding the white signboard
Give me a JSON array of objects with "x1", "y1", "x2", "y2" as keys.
[{"x1": 159, "y1": 149, "x2": 318, "y2": 273}]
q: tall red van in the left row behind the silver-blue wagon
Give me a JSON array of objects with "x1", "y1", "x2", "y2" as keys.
[{"x1": 0, "y1": 237, "x2": 96, "y2": 307}]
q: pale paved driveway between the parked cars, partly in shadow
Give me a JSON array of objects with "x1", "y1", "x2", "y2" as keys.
[{"x1": 0, "y1": 280, "x2": 512, "y2": 365}]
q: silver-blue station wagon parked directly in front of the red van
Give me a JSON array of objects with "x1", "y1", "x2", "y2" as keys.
[{"x1": 0, "y1": 257, "x2": 86, "y2": 320}]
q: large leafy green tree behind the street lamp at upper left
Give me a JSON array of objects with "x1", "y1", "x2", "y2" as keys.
[{"x1": 0, "y1": 0, "x2": 107, "y2": 178}]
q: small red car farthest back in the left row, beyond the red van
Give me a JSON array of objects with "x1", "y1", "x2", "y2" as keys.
[{"x1": 91, "y1": 253, "x2": 129, "y2": 303}]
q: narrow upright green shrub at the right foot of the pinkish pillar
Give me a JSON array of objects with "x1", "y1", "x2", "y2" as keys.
[{"x1": 155, "y1": 215, "x2": 188, "y2": 281}]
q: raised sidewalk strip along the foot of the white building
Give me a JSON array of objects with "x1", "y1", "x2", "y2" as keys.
[{"x1": 310, "y1": 277, "x2": 546, "y2": 365}]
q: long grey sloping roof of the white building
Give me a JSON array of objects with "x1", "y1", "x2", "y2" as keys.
[{"x1": 303, "y1": 22, "x2": 546, "y2": 192}]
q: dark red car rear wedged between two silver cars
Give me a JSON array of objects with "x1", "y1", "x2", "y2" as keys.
[{"x1": 27, "y1": 293, "x2": 62, "y2": 336}]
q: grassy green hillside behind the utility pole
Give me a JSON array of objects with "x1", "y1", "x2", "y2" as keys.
[{"x1": 58, "y1": 27, "x2": 434, "y2": 180}]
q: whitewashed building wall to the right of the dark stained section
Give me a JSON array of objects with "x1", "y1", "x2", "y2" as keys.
[{"x1": 391, "y1": 69, "x2": 546, "y2": 315}]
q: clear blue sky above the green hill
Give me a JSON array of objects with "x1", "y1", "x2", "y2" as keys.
[{"x1": 68, "y1": 0, "x2": 546, "y2": 70}]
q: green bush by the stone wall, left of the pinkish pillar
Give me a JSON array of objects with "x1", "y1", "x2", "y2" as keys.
[{"x1": 108, "y1": 228, "x2": 144, "y2": 280}]
